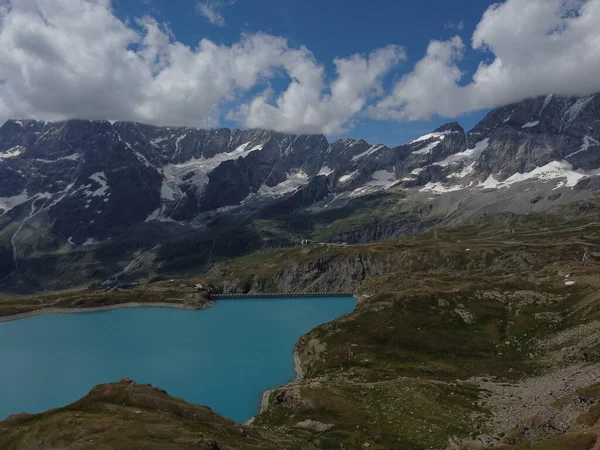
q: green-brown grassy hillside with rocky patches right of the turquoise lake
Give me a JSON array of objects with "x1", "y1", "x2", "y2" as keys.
[{"x1": 0, "y1": 215, "x2": 600, "y2": 450}]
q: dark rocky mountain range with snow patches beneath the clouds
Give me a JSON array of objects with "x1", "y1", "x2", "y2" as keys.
[{"x1": 0, "y1": 95, "x2": 600, "y2": 292}]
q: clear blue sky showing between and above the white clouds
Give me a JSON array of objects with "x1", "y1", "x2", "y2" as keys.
[{"x1": 114, "y1": 0, "x2": 496, "y2": 145}]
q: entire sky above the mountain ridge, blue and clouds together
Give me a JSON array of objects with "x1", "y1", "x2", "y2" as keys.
[{"x1": 0, "y1": 0, "x2": 600, "y2": 145}]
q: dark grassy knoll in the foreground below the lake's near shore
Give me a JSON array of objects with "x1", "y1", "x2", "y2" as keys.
[{"x1": 0, "y1": 380, "x2": 314, "y2": 450}]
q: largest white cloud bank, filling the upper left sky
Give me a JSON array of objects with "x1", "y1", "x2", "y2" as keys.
[{"x1": 0, "y1": 0, "x2": 287, "y2": 126}]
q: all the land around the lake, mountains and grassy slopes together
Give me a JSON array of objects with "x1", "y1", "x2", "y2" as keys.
[{"x1": 0, "y1": 94, "x2": 600, "y2": 450}]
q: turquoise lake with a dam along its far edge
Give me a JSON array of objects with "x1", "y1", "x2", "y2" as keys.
[{"x1": 0, "y1": 297, "x2": 356, "y2": 422}]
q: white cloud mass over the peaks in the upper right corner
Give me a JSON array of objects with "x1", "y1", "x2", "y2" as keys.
[{"x1": 370, "y1": 0, "x2": 600, "y2": 120}]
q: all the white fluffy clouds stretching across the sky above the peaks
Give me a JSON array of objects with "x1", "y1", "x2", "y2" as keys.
[{"x1": 0, "y1": 0, "x2": 600, "y2": 134}]
